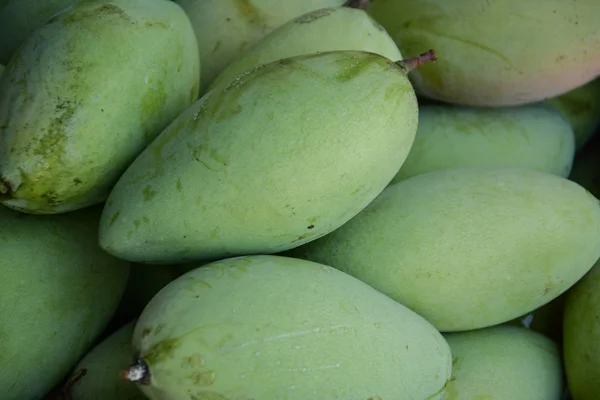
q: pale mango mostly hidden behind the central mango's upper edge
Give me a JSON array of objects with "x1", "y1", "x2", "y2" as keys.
[{"x1": 209, "y1": 6, "x2": 402, "y2": 90}]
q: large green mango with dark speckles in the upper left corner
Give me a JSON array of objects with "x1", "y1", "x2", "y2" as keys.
[{"x1": 0, "y1": 0, "x2": 199, "y2": 214}]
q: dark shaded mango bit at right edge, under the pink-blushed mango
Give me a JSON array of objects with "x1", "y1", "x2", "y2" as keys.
[{"x1": 544, "y1": 78, "x2": 600, "y2": 149}]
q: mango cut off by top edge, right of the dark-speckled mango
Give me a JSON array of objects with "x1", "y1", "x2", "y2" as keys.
[{"x1": 175, "y1": 0, "x2": 345, "y2": 93}]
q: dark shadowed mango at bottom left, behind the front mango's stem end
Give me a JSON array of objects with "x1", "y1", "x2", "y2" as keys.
[{"x1": 64, "y1": 321, "x2": 147, "y2": 400}]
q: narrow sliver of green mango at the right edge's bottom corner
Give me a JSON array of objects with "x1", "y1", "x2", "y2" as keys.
[{"x1": 563, "y1": 260, "x2": 600, "y2": 400}]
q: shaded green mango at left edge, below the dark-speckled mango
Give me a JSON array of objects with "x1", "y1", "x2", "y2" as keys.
[{"x1": 0, "y1": 206, "x2": 129, "y2": 400}]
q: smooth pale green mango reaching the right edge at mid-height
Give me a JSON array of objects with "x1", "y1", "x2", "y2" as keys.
[{"x1": 288, "y1": 168, "x2": 600, "y2": 332}]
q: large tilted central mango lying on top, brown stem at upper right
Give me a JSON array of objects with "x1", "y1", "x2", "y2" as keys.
[{"x1": 100, "y1": 51, "x2": 418, "y2": 264}]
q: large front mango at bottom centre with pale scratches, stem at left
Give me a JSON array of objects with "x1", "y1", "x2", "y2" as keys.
[{"x1": 133, "y1": 255, "x2": 451, "y2": 400}]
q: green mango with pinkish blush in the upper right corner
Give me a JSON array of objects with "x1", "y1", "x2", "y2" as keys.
[{"x1": 367, "y1": 0, "x2": 600, "y2": 107}]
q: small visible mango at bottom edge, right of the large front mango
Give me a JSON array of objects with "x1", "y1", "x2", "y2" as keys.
[{"x1": 444, "y1": 326, "x2": 563, "y2": 400}]
